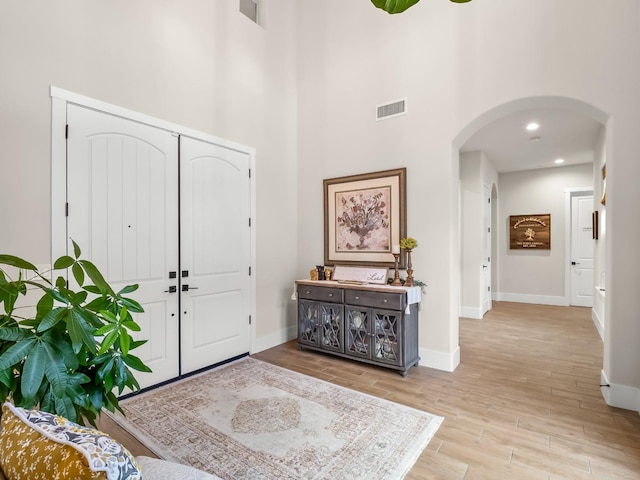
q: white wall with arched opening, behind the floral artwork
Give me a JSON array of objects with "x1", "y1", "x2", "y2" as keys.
[{"x1": 298, "y1": 0, "x2": 640, "y2": 402}]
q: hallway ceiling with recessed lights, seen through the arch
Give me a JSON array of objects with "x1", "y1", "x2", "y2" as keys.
[{"x1": 460, "y1": 109, "x2": 603, "y2": 173}]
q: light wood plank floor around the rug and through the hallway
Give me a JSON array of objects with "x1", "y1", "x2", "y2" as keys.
[{"x1": 96, "y1": 302, "x2": 640, "y2": 480}]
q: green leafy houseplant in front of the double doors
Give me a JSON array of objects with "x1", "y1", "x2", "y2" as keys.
[{"x1": 0, "y1": 242, "x2": 151, "y2": 425}]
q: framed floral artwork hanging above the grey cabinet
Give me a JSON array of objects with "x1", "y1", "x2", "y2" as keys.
[{"x1": 323, "y1": 168, "x2": 407, "y2": 268}]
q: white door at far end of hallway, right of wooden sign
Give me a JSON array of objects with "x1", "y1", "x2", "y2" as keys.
[{"x1": 571, "y1": 196, "x2": 593, "y2": 307}]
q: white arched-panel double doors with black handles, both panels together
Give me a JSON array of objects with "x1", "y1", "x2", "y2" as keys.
[{"x1": 67, "y1": 104, "x2": 251, "y2": 388}]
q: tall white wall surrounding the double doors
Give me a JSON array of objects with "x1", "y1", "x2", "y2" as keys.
[{"x1": 0, "y1": 0, "x2": 297, "y2": 349}]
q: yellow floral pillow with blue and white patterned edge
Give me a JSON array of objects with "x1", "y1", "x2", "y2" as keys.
[{"x1": 0, "y1": 402, "x2": 142, "y2": 480}]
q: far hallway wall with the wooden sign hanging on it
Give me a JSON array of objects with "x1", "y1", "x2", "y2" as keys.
[{"x1": 496, "y1": 164, "x2": 593, "y2": 305}]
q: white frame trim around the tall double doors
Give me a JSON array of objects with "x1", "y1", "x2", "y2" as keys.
[{"x1": 50, "y1": 85, "x2": 258, "y2": 353}]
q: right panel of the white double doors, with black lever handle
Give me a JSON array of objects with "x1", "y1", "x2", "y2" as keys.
[{"x1": 180, "y1": 137, "x2": 251, "y2": 374}]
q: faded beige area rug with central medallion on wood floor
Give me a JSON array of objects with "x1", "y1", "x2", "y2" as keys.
[{"x1": 116, "y1": 357, "x2": 443, "y2": 480}]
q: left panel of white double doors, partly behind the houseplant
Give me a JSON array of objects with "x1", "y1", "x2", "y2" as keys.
[{"x1": 67, "y1": 105, "x2": 179, "y2": 387}]
